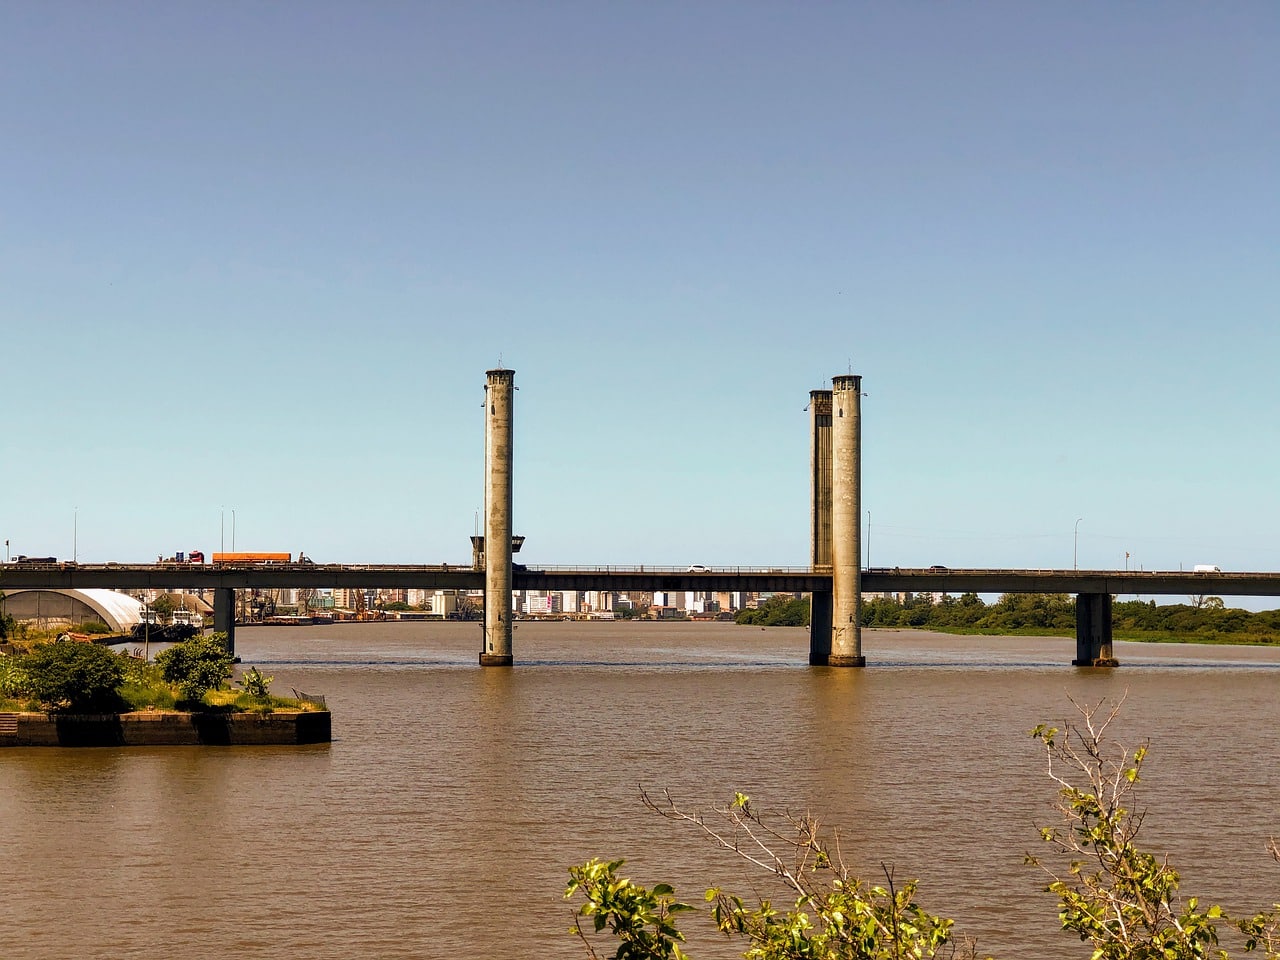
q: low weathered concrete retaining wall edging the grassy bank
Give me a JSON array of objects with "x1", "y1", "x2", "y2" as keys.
[{"x1": 0, "y1": 710, "x2": 332, "y2": 746}]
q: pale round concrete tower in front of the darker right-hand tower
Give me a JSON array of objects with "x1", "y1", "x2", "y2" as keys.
[{"x1": 827, "y1": 374, "x2": 867, "y2": 667}]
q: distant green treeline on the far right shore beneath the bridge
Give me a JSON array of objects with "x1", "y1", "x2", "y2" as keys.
[{"x1": 736, "y1": 594, "x2": 1280, "y2": 643}]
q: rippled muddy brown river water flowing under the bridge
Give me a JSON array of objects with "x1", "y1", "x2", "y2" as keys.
[{"x1": 0, "y1": 622, "x2": 1280, "y2": 960}]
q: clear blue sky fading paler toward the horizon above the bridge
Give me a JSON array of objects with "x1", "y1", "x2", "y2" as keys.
[{"x1": 0, "y1": 0, "x2": 1280, "y2": 605}]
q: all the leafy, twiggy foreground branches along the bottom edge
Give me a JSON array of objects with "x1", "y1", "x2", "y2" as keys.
[{"x1": 564, "y1": 701, "x2": 1280, "y2": 960}]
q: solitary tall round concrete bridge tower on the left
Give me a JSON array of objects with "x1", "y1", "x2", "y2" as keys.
[{"x1": 480, "y1": 370, "x2": 516, "y2": 667}]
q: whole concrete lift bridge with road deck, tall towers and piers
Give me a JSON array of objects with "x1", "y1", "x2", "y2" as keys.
[{"x1": 0, "y1": 369, "x2": 1280, "y2": 667}]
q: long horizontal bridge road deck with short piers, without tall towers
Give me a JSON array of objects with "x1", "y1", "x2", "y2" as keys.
[{"x1": 0, "y1": 563, "x2": 1280, "y2": 666}]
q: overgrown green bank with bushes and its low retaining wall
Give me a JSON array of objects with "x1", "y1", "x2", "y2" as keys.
[{"x1": 0, "y1": 634, "x2": 330, "y2": 746}]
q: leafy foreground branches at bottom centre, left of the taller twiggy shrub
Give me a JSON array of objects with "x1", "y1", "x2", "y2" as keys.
[{"x1": 564, "y1": 790, "x2": 973, "y2": 960}]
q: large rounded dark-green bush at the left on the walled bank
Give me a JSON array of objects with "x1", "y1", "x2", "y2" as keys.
[{"x1": 19, "y1": 643, "x2": 124, "y2": 713}]
